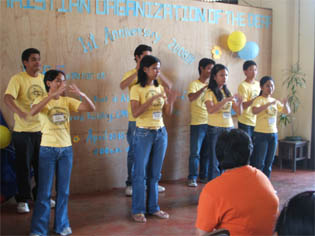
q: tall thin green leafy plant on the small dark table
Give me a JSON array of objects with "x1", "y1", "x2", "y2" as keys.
[{"x1": 279, "y1": 62, "x2": 306, "y2": 140}]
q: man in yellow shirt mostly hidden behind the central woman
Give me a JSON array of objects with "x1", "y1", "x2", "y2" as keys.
[{"x1": 120, "y1": 44, "x2": 171, "y2": 196}]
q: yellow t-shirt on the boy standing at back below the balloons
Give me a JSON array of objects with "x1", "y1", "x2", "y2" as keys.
[{"x1": 238, "y1": 80, "x2": 260, "y2": 126}]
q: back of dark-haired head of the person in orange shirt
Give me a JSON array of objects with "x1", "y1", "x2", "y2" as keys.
[{"x1": 215, "y1": 129, "x2": 253, "y2": 170}]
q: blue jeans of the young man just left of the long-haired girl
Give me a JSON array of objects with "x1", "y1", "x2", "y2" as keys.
[{"x1": 188, "y1": 124, "x2": 209, "y2": 180}]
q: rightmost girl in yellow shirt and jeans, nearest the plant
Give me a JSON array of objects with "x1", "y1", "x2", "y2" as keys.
[{"x1": 251, "y1": 76, "x2": 291, "y2": 178}]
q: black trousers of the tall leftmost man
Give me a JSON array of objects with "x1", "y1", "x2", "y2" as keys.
[{"x1": 12, "y1": 132, "x2": 42, "y2": 202}]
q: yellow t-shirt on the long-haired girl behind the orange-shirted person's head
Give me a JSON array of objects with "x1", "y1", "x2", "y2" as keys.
[{"x1": 205, "y1": 89, "x2": 233, "y2": 128}]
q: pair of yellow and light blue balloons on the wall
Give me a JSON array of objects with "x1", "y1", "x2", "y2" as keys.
[{"x1": 227, "y1": 31, "x2": 259, "y2": 60}]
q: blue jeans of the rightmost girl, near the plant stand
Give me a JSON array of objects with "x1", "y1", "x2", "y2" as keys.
[{"x1": 250, "y1": 132, "x2": 278, "y2": 178}]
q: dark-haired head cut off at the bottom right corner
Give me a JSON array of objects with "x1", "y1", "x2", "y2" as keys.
[{"x1": 275, "y1": 191, "x2": 315, "y2": 235}]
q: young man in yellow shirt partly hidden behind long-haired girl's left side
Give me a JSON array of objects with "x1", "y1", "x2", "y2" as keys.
[{"x1": 188, "y1": 58, "x2": 215, "y2": 187}]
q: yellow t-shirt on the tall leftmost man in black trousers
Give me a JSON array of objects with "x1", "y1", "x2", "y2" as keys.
[{"x1": 5, "y1": 72, "x2": 46, "y2": 132}]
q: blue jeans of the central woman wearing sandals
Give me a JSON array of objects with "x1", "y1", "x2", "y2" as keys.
[{"x1": 131, "y1": 127, "x2": 167, "y2": 214}]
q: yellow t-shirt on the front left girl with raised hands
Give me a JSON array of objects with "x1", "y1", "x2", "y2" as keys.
[{"x1": 34, "y1": 97, "x2": 81, "y2": 147}]
